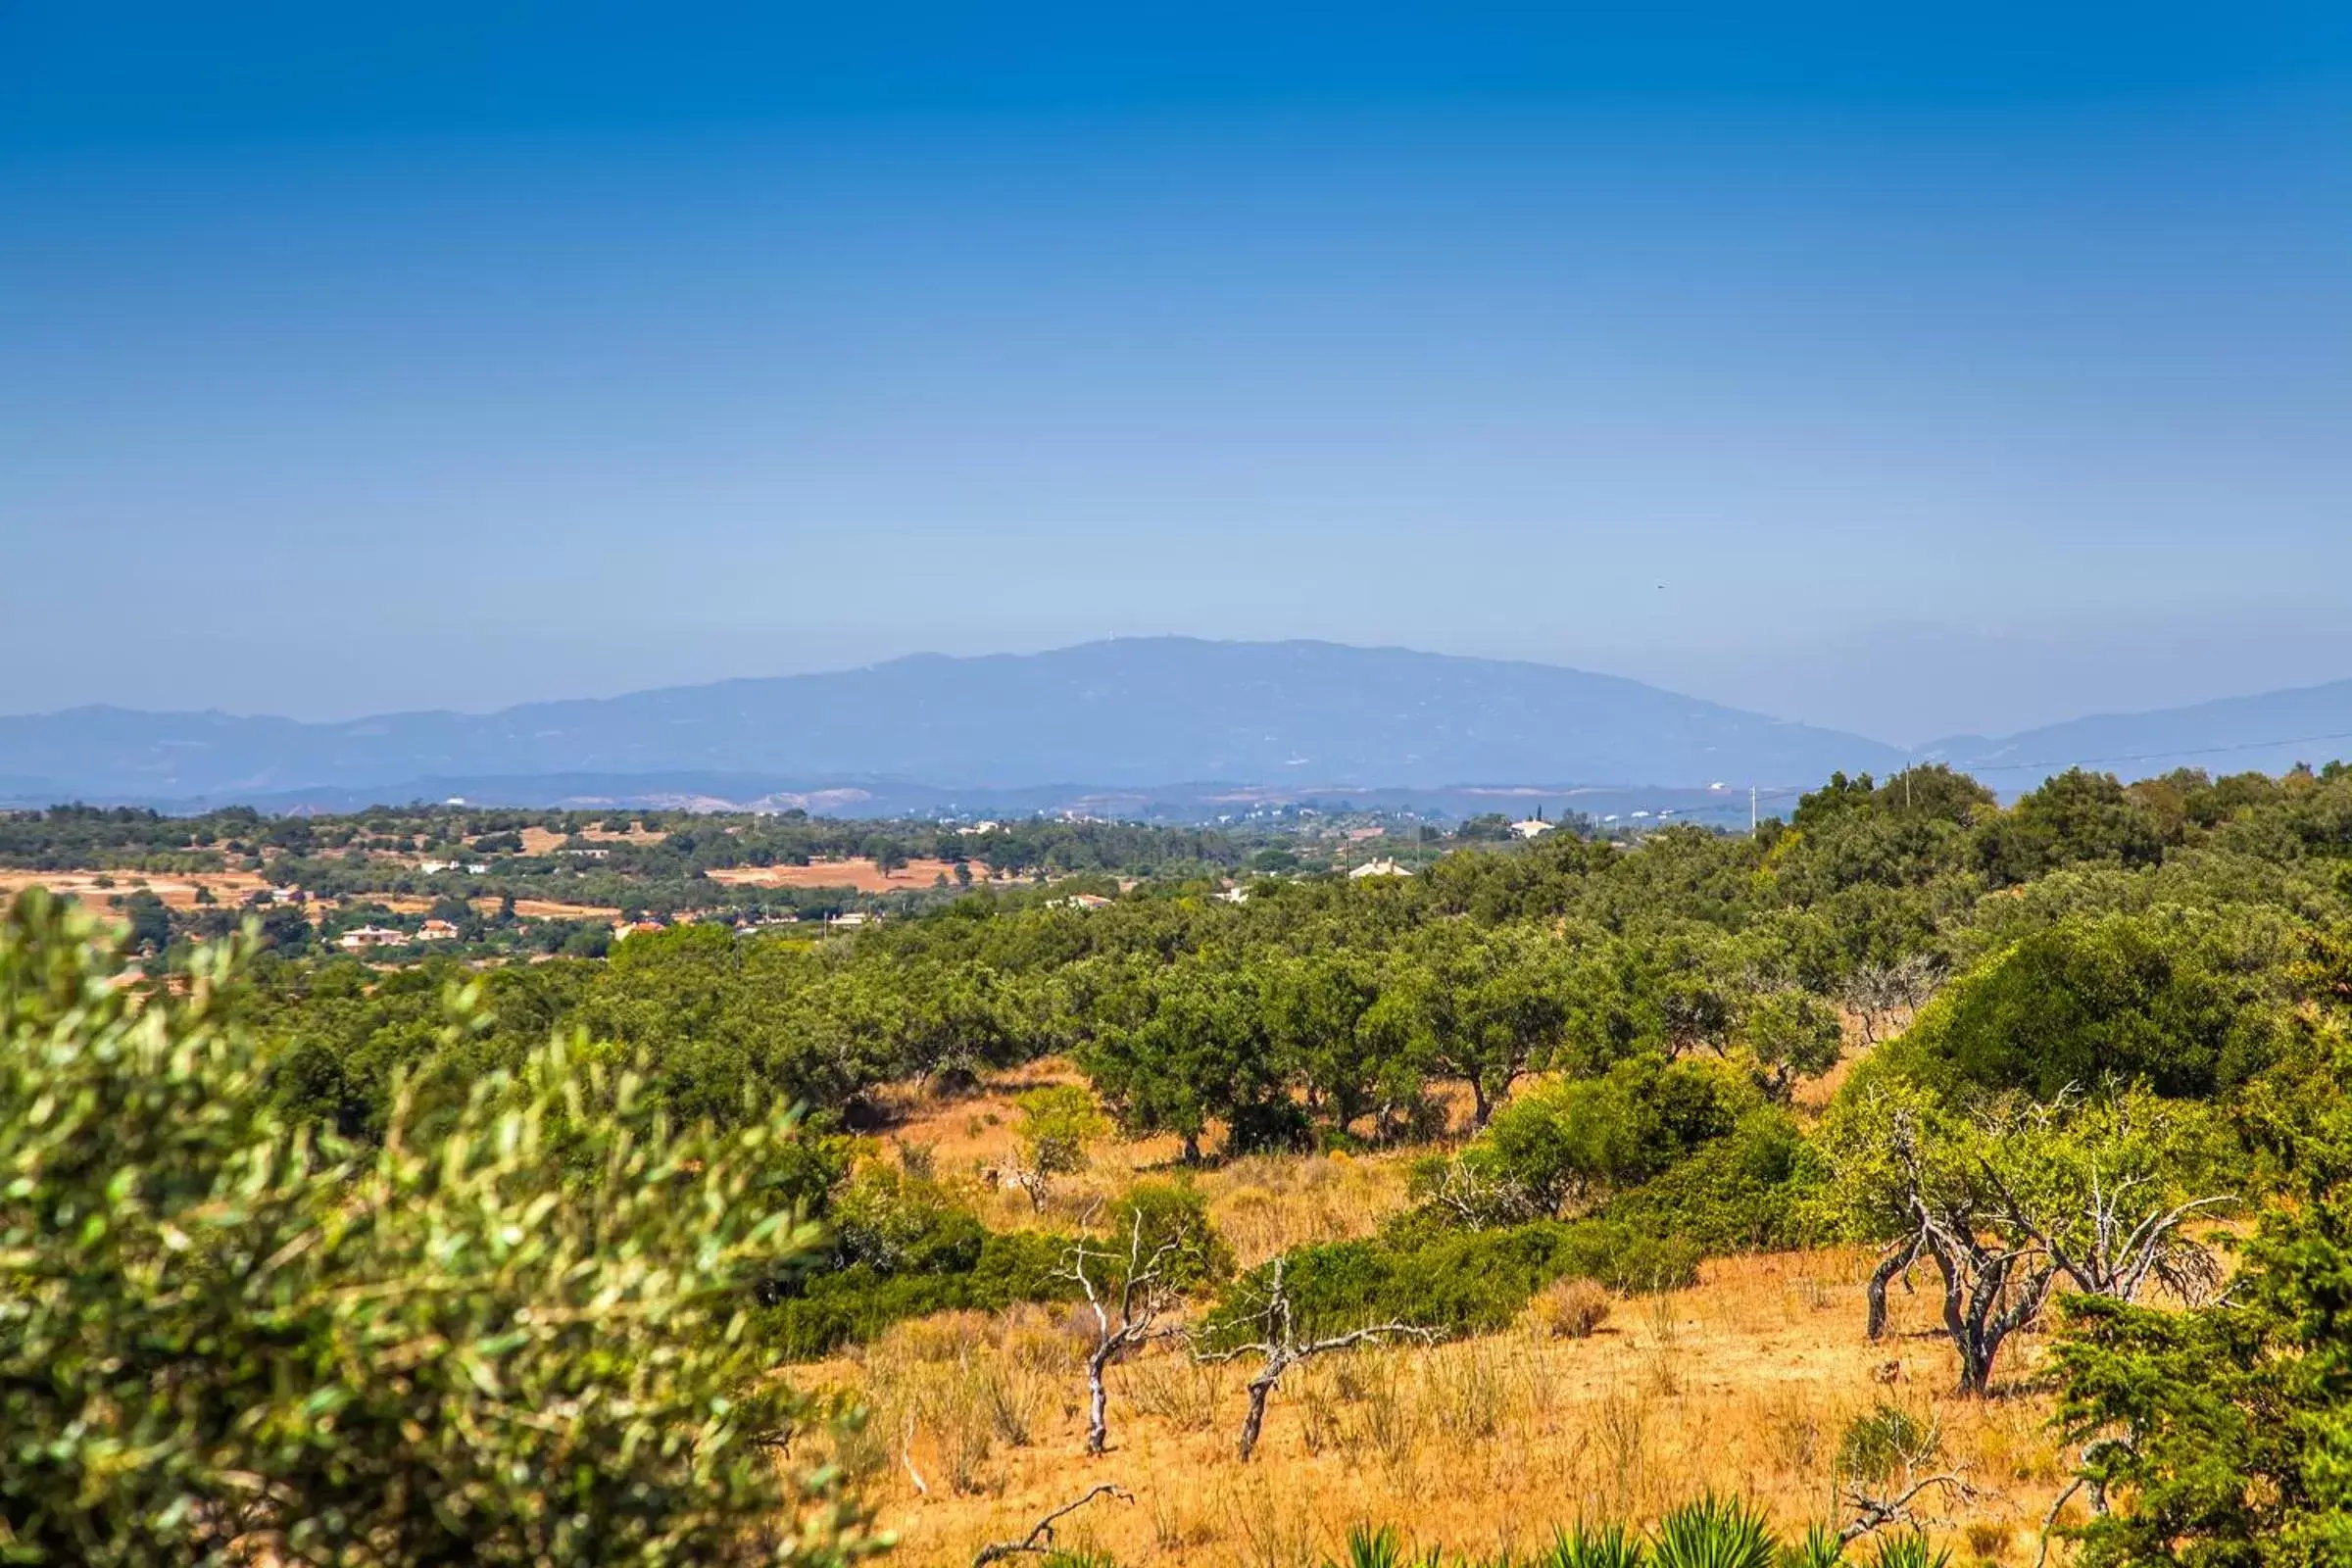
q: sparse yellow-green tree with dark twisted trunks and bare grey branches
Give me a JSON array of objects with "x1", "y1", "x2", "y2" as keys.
[{"x1": 1816, "y1": 1079, "x2": 2228, "y2": 1396}]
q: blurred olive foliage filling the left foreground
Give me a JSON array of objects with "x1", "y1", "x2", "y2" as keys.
[{"x1": 0, "y1": 891, "x2": 875, "y2": 1568}]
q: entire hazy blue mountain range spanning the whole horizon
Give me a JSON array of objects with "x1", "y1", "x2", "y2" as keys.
[{"x1": 0, "y1": 637, "x2": 2352, "y2": 815}]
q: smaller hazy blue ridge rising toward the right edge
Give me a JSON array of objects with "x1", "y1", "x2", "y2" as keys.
[{"x1": 1919, "y1": 679, "x2": 2352, "y2": 792}]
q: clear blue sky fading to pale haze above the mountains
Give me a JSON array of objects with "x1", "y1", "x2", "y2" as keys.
[{"x1": 0, "y1": 0, "x2": 2352, "y2": 741}]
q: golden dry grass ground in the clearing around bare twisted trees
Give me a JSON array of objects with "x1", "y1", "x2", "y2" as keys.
[{"x1": 793, "y1": 1065, "x2": 2065, "y2": 1568}]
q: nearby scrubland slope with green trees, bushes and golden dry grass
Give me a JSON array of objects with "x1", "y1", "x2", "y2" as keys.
[{"x1": 0, "y1": 766, "x2": 2352, "y2": 1568}]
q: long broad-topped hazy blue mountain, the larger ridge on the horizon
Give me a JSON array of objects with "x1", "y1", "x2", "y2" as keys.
[{"x1": 0, "y1": 637, "x2": 1905, "y2": 800}]
